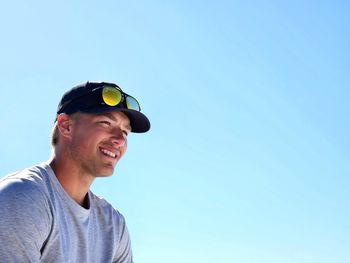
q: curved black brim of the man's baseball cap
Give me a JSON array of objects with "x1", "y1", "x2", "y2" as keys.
[{"x1": 81, "y1": 106, "x2": 151, "y2": 133}]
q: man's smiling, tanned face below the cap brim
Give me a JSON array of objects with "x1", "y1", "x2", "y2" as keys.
[{"x1": 68, "y1": 112, "x2": 131, "y2": 177}]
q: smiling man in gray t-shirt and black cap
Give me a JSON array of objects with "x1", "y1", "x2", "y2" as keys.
[{"x1": 0, "y1": 82, "x2": 150, "y2": 263}]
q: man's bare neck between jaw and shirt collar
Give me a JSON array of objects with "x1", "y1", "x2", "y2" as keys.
[{"x1": 49, "y1": 153, "x2": 94, "y2": 208}]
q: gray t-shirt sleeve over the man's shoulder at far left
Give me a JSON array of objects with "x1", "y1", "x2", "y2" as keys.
[{"x1": 0, "y1": 178, "x2": 52, "y2": 263}]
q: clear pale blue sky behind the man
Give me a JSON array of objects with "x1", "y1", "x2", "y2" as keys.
[{"x1": 0, "y1": 0, "x2": 350, "y2": 263}]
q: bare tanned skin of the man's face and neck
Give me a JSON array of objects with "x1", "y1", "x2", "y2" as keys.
[{"x1": 50, "y1": 112, "x2": 131, "y2": 207}]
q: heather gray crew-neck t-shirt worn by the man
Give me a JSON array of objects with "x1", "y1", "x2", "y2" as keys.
[{"x1": 0, "y1": 163, "x2": 133, "y2": 263}]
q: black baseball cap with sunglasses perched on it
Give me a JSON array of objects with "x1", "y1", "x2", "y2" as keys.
[{"x1": 56, "y1": 81, "x2": 151, "y2": 133}]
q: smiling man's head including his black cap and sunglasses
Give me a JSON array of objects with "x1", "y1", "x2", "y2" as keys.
[{"x1": 52, "y1": 82, "x2": 150, "y2": 176}]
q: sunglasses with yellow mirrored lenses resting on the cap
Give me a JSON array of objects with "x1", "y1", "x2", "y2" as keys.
[{"x1": 92, "y1": 85, "x2": 141, "y2": 111}]
